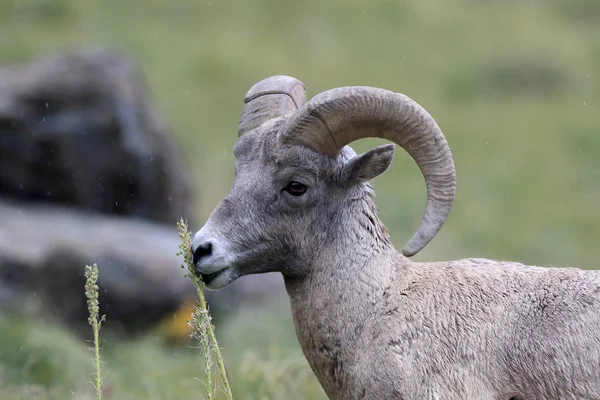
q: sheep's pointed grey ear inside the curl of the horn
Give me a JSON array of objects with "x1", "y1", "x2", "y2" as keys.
[{"x1": 340, "y1": 144, "x2": 396, "y2": 187}]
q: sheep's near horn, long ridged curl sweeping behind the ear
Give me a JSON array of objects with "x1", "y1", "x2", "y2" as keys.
[{"x1": 279, "y1": 86, "x2": 456, "y2": 257}]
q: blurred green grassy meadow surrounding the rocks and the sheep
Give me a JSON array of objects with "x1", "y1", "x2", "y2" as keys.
[{"x1": 0, "y1": 0, "x2": 600, "y2": 400}]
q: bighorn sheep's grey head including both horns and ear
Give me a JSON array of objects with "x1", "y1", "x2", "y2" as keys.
[{"x1": 192, "y1": 76, "x2": 456, "y2": 289}]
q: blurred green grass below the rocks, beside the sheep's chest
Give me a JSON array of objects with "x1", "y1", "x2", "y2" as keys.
[{"x1": 0, "y1": 305, "x2": 325, "y2": 400}]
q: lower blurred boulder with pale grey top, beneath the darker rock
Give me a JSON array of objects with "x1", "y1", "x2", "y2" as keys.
[{"x1": 0, "y1": 199, "x2": 285, "y2": 333}]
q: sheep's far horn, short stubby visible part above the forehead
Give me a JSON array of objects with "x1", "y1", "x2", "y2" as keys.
[{"x1": 238, "y1": 75, "x2": 306, "y2": 137}]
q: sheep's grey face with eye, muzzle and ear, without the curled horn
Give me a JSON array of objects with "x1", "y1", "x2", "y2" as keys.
[{"x1": 192, "y1": 120, "x2": 394, "y2": 289}]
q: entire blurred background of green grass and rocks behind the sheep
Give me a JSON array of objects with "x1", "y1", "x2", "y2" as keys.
[{"x1": 0, "y1": 0, "x2": 600, "y2": 399}]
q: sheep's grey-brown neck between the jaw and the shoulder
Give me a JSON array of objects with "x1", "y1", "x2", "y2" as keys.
[{"x1": 286, "y1": 191, "x2": 403, "y2": 391}]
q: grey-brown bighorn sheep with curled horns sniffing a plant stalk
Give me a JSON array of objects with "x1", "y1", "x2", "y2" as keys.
[{"x1": 192, "y1": 76, "x2": 600, "y2": 400}]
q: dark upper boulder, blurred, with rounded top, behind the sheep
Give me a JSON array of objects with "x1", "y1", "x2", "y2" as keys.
[{"x1": 0, "y1": 50, "x2": 192, "y2": 224}]
